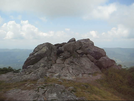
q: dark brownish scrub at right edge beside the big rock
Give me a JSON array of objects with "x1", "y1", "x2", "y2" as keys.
[{"x1": 98, "y1": 68, "x2": 134, "y2": 100}]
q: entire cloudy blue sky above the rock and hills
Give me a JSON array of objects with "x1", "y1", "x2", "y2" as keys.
[{"x1": 0, "y1": 0, "x2": 134, "y2": 49}]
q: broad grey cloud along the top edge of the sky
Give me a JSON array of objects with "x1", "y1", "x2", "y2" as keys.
[{"x1": 0, "y1": 0, "x2": 107, "y2": 18}]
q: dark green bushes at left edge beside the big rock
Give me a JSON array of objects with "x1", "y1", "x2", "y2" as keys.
[{"x1": 0, "y1": 66, "x2": 21, "y2": 74}]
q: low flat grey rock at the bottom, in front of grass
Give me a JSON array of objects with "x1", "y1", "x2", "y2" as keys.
[{"x1": 6, "y1": 84, "x2": 80, "y2": 101}]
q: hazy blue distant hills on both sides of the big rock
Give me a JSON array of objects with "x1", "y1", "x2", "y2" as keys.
[{"x1": 0, "y1": 48, "x2": 134, "y2": 69}]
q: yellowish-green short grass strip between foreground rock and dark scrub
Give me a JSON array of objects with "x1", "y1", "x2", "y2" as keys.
[{"x1": 43, "y1": 78, "x2": 122, "y2": 100}]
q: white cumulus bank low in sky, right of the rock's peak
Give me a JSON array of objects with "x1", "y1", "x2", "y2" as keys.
[{"x1": 82, "y1": 25, "x2": 134, "y2": 41}]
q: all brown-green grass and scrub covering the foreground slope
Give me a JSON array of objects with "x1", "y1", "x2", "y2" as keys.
[{"x1": 0, "y1": 68, "x2": 134, "y2": 100}]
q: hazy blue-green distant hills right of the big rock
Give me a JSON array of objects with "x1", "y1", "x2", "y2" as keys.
[{"x1": 104, "y1": 48, "x2": 134, "y2": 67}]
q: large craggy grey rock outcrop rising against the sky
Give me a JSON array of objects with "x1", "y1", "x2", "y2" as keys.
[{"x1": 23, "y1": 38, "x2": 121, "y2": 79}]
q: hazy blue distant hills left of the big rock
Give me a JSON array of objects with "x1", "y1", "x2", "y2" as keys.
[{"x1": 0, "y1": 49, "x2": 32, "y2": 69}]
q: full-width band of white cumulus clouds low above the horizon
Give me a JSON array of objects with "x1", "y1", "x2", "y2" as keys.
[{"x1": 0, "y1": 20, "x2": 134, "y2": 42}]
